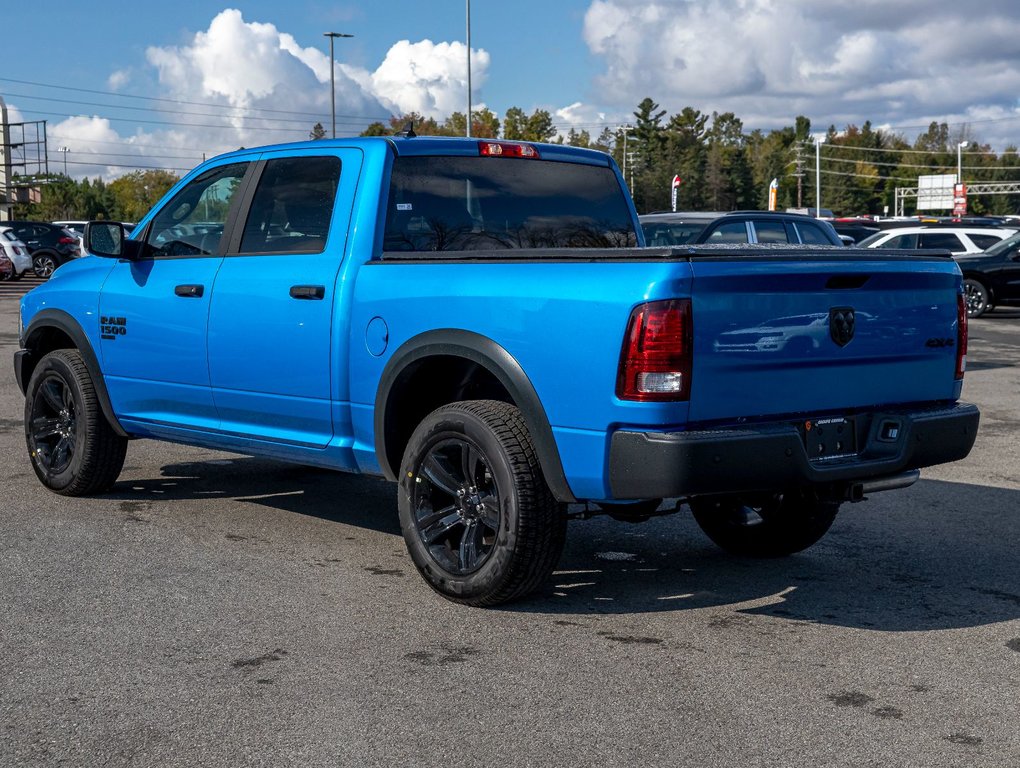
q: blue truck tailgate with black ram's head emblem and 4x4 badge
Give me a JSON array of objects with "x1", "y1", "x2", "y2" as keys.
[{"x1": 690, "y1": 250, "x2": 961, "y2": 423}]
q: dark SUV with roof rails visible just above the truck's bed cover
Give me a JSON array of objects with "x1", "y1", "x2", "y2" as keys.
[{"x1": 639, "y1": 211, "x2": 844, "y2": 246}]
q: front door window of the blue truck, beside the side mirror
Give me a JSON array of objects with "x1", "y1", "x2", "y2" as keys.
[{"x1": 146, "y1": 162, "x2": 248, "y2": 256}]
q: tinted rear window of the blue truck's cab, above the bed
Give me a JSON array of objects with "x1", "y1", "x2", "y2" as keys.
[{"x1": 384, "y1": 157, "x2": 638, "y2": 251}]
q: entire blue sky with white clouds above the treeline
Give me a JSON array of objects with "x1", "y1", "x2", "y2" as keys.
[{"x1": 0, "y1": 0, "x2": 1020, "y2": 176}]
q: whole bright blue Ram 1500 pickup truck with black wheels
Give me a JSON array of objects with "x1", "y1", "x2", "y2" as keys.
[{"x1": 15, "y1": 133, "x2": 978, "y2": 606}]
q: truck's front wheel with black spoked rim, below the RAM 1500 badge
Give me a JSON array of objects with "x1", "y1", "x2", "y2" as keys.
[{"x1": 24, "y1": 350, "x2": 128, "y2": 496}]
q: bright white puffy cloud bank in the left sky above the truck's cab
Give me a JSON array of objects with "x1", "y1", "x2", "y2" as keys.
[{"x1": 35, "y1": 8, "x2": 490, "y2": 177}]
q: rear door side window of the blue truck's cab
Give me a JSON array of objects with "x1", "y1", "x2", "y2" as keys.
[{"x1": 241, "y1": 157, "x2": 340, "y2": 253}]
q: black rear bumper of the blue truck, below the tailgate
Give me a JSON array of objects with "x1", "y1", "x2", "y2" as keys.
[{"x1": 609, "y1": 403, "x2": 980, "y2": 499}]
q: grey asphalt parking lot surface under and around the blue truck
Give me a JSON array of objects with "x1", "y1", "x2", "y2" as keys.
[{"x1": 0, "y1": 285, "x2": 1020, "y2": 768}]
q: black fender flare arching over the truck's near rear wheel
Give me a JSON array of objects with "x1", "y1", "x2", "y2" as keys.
[{"x1": 374, "y1": 328, "x2": 577, "y2": 502}]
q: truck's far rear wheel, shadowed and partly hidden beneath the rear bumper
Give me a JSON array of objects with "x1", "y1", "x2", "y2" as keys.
[{"x1": 691, "y1": 491, "x2": 839, "y2": 557}]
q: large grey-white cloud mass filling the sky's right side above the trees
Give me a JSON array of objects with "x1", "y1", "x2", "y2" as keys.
[{"x1": 583, "y1": 0, "x2": 1020, "y2": 143}]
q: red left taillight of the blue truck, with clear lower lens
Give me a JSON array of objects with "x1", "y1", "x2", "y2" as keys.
[{"x1": 616, "y1": 299, "x2": 694, "y2": 402}]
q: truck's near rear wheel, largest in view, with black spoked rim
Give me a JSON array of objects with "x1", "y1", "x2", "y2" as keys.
[{"x1": 398, "y1": 400, "x2": 566, "y2": 606}]
